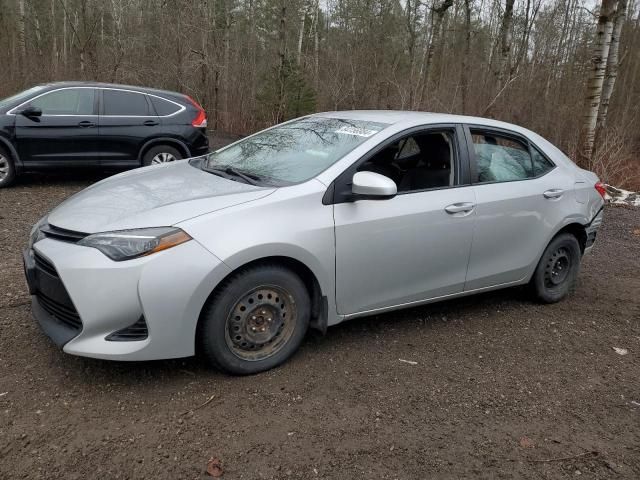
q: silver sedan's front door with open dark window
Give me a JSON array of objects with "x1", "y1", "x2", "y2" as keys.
[{"x1": 334, "y1": 128, "x2": 475, "y2": 315}]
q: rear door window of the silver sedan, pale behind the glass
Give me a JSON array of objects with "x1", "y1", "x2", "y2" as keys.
[{"x1": 471, "y1": 130, "x2": 535, "y2": 183}]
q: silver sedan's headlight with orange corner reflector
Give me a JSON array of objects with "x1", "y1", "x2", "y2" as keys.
[{"x1": 78, "y1": 227, "x2": 191, "y2": 262}]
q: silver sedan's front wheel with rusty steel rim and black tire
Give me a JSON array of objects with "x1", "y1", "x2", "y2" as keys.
[{"x1": 197, "y1": 264, "x2": 311, "y2": 375}]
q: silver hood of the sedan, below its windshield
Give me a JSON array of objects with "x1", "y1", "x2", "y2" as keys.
[{"x1": 48, "y1": 161, "x2": 275, "y2": 233}]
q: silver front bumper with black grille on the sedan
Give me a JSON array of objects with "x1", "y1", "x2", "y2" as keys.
[{"x1": 24, "y1": 238, "x2": 230, "y2": 360}]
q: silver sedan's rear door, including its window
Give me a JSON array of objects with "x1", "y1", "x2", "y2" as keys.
[{"x1": 465, "y1": 126, "x2": 575, "y2": 291}]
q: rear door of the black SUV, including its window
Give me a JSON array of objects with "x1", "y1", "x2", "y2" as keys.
[{"x1": 99, "y1": 88, "x2": 161, "y2": 166}]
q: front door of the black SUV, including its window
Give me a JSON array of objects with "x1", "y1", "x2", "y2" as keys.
[{"x1": 15, "y1": 87, "x2": 100, "y2": 167}]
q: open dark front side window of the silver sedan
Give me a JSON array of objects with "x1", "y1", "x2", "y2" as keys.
[{"x1": 358, "y1": 131, "x2": 455, "y2": 193}]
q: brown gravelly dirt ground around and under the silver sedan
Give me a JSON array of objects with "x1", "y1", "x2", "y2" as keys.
[{"x1": 0, "y1": 168, "x2": 640, "y2": 479}]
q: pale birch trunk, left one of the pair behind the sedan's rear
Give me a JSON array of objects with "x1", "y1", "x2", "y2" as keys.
[{"x1": 579, "y1": 0, "x2": 617, "y2": 166}]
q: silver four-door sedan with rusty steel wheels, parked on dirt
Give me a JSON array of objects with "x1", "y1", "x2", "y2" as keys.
[{"x1": 24, "y1": 111, "x2": 604, "y2": 374}]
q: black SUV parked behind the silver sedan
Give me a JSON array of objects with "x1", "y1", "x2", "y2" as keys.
[{"x1": 0, "y1": 82, "x2": 209, "y2": 188}]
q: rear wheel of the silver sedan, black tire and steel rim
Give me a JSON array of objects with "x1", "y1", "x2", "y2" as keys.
[{"x1": 530, "y1": 233, "x2": 582, "y2": 303}]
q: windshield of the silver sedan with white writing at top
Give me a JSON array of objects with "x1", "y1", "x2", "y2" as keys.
[{"x1": 204, "y1": 117, "x2": 387, "y2": 185}]
